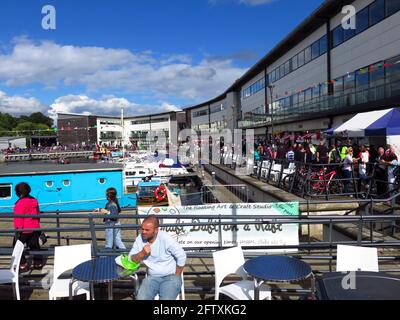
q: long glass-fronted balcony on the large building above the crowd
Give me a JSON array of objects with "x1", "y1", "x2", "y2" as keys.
[{"x1": 238, "y1": 80, "x2": 400, "y2": 129}]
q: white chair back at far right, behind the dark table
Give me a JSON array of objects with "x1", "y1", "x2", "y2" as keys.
[{"x1": 336, "y1": 245, "x2": 379, "y2": 272}]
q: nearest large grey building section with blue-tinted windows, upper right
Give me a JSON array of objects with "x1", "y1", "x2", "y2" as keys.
[{"x1": 234, "y1": 0, "x2": 400, "y2": 144}]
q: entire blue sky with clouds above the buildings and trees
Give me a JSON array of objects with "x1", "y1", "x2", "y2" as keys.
[{"x1": 0, "y1": 0, "x2": 323, "y2": 117}]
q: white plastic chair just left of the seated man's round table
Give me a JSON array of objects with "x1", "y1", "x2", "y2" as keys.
[{"x1": 49, "y1": 243, "x2": 92, "y2": 300}]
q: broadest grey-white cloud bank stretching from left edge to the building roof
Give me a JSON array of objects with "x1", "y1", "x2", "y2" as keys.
[{"x1": 0, "y1": 38, "x2": 247, "y2": 102}]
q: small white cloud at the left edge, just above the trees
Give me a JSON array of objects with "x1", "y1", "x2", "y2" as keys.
[{"x1": 0, "y1": 91, "x2": 48, "y2": 115}]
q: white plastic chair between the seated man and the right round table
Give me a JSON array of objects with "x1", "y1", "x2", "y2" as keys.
[{"x1": 213, "y1": 246, "x2": 271, "y2": 300}]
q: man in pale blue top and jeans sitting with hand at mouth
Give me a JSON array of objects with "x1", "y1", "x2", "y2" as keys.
[{"x1": 129, "y1": 214, "x2": 186, "y2": 300}]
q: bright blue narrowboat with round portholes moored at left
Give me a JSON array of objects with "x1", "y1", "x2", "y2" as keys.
[{"x1": 0, "y1": 163, "x2": 136, "y2": 212}]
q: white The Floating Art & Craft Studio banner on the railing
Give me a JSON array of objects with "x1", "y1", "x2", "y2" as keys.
[{"x1": 138, "y1": 202, "x2": 299, "y2": 251}]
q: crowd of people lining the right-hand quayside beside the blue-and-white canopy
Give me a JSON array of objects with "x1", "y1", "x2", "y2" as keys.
[{"x1": 254, "y1": 139, "x2": 400, "y2": 197}]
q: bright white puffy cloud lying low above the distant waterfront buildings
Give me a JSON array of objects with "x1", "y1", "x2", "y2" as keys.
[{"x1": 49, "y1": 95, "x2": 180, "y2": 118}]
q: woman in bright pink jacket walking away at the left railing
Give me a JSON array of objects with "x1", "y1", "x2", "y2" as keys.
[{"x1": 14, "y1": 182, "x2": 43, "y2": 271}]
